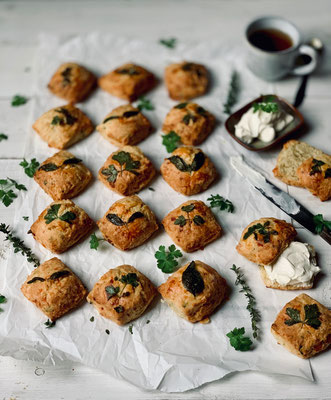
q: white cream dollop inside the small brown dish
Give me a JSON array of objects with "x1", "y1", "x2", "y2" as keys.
[{"x1": 235, "y1": 107, "x2": 293, "y2": 144}]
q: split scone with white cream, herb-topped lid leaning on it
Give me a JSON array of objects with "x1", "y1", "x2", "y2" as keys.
[{"x1": 236, "y1": 218, "x2": 320, "y2": 290}]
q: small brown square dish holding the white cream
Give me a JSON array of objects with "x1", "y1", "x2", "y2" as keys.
[{"x1": 225, "y1": 94, "x2": 303, "y2": 151}]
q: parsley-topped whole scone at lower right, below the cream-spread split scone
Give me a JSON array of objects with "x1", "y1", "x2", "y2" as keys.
[{"x1": 271, "y1": 293, "x2": 331, "y2": 358}]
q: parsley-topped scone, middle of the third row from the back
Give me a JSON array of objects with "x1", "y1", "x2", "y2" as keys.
[{"x1": 98, "y1": 146, "x2": 156, "y2": 196}]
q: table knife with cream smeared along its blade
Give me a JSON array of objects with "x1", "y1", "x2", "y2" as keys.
[{"x1": 230, "y1": 156, "x2": 331, "y2": 245}]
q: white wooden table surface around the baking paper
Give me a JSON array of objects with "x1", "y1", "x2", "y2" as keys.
[{"x1": 0, "y1": 0, "x2": 331, "y2": 400}]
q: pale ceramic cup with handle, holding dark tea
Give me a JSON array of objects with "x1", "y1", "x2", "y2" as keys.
[{"x1": 246, "y1": 17, "x2": 318, "y2": 81}]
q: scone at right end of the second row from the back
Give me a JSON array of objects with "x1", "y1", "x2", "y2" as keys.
[{"x1": 162, "y1": 103, "x2": 215, "y2": 146}]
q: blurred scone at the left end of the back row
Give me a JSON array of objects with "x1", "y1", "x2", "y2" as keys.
[{"x1": 48, "y1": 63, "x2": 96, "y2": 103}]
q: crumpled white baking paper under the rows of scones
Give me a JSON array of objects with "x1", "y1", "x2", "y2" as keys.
[{"x1": 0, "y1": 33, "x2": 330, "y2": 392}]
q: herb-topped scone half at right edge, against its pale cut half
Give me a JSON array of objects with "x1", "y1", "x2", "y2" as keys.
[{"x1": 297, "y1": 154, "x2": 331, "y2": 201}]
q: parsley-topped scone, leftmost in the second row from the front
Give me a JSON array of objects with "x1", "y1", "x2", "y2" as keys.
[{"x1": 30, "y1": 200, "x2": 94, "y2": 254}]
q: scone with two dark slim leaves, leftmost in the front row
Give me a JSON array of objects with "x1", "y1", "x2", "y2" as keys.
[{"x1": 21, "y1": 257, "x2": 87, "y2": 321}]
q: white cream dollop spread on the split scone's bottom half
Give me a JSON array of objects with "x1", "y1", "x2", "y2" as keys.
[{"x1": 264, "y1": 242, "x2": 320, "y2": 286}]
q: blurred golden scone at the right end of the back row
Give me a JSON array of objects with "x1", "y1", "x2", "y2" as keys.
[{"x1": 164, "y1": 61, "x2": 209, "y2": 100}]
